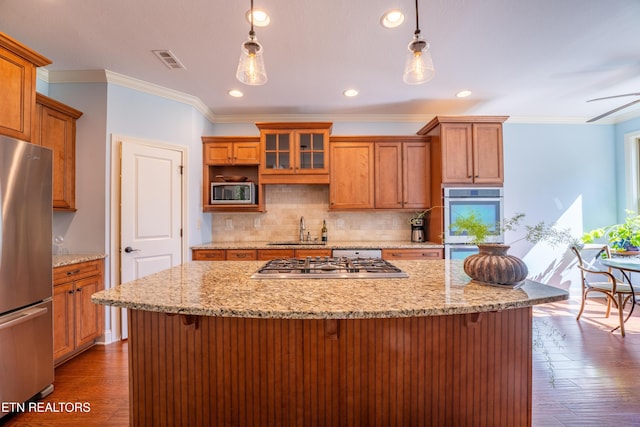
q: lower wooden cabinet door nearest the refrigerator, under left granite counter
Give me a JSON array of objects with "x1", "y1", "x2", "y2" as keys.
[{"x1": 53, "y1": 282, "x2": 75, "y2": 361}]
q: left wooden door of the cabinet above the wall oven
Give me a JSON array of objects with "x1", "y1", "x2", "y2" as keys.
[{"x1": 441, "y1": 123, "x2": 473, "y2": 184}]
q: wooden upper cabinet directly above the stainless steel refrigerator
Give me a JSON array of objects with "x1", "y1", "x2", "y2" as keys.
[{"x1": 0, "y1": 33, "x2": 51, "y2": 141}]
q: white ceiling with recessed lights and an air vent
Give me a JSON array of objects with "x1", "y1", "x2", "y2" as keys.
[{"x1": 0, "y1": 0, "x2": 640, "y2": 123}]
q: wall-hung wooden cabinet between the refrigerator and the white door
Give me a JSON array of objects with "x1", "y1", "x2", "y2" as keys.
[{"x1": 31, "y1": 93, "x2": 82, "y2": 211}]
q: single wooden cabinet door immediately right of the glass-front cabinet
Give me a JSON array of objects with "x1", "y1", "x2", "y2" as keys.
[{"x1": 329, "y1": 141, "x2": 374, "y2": 209}]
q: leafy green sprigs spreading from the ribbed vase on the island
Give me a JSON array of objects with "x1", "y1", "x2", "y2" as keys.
[{"x1": 449, "y1": 211, "x2": 577, "y2": 247}]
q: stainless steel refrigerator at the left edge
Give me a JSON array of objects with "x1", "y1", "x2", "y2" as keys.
[{"x1": 0, "y1": 136, "x2": 53, "y2": 418}]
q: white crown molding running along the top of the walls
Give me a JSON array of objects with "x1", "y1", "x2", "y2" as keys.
[{"x1": 37, "y1": 68, "x2": 640, "y2": 125}]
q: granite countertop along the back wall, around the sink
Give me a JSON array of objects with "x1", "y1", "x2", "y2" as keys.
[{"x1": 191, "y1": 239, "x2": 444, "y2": 249}]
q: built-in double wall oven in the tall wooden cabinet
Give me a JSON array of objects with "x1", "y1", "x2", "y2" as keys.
[{"x1": 444, "y1": 187, "x2": 504, "y2": 259}]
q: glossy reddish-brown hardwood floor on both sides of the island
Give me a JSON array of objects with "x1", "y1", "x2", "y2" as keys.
[{"x1": 0, "y1": 298, "x2": 640, "y2": 427}]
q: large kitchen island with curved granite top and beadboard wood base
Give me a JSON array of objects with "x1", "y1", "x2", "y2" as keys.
[{"x1": 92, "y1": 260, "x2": 568, "y2": 426}]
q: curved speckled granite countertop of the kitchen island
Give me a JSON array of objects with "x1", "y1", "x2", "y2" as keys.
[{"x1": 91, "y1": 260, "x2": 568, "y2": 319}]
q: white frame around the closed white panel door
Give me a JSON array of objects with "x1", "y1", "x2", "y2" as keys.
[{"x1": 105, "y1": 134, "x2": 189, "y2": 343}]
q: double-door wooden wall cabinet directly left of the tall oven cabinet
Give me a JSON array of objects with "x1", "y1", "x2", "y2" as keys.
[{"x1": 374, "y1": 137, "x2": 431, "y2": 210}]
